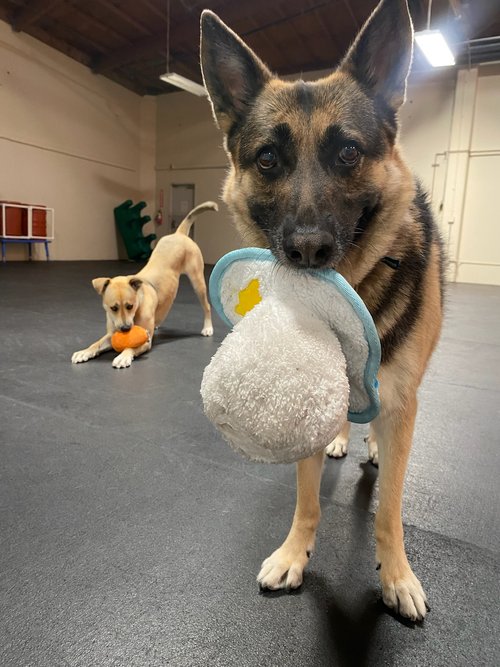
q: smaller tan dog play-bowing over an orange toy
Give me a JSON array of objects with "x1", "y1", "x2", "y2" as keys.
[{"x1": 71, "y1": 201, "x2": 218, "y2": 368}]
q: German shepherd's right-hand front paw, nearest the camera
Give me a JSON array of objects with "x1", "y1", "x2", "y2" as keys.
[{"x1": 380, "y1": 566, "x2": 429, "y2": 621}]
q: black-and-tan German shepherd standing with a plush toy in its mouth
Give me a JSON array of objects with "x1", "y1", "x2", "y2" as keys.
[{"x1": 201, "y1": 0, "x2": 444, "y2": 620}]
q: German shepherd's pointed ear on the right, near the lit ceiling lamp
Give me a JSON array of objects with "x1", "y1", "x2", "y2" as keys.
[{"x1": 340, "y1": 0, "x2": 413, "y2": 111}]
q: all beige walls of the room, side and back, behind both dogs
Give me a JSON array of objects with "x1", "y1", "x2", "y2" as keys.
[{"x1": 0, "y1": 15, "x2": 500, "y2": 284}]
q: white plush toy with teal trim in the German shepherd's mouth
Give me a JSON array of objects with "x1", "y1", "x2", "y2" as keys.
[{"x1": 201, "y1": 248, "x2": 380, "y2": 463}]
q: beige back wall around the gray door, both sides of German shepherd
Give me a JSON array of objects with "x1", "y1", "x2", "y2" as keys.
[{"x1": 157, "y1": 65, "x2": 500, "y2": 284}]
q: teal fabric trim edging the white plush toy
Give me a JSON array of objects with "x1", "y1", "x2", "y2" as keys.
[{"x1": 209, "y1": 248, "x2": 381, "y2": 424}]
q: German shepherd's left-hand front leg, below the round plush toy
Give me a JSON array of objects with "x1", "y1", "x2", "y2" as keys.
[{"x1": 257, "y1": 452, "x2": 324, "y2": 591}]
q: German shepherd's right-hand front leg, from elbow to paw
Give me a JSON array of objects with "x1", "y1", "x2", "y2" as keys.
[{"x1": 373, "y1": 395, "x2": 427, "y2": 621}]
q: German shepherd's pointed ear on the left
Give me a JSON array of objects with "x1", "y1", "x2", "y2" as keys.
[{"x1": 200, "y1": 9, "x2": 271, "y2": 134}]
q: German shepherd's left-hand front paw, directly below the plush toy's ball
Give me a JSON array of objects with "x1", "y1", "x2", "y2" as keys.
[{"x1": 257, "y1": 544, "x2": 311, "y2": 591}]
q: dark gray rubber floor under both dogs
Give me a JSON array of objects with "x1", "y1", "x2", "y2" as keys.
[{"x1": 0, "y1": 262, "x2": 500, "y2": 667}]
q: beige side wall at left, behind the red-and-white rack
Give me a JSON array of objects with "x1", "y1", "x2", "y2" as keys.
[{"x1": 0, "y1": 21, "x2": 155, "y2": 259}]
